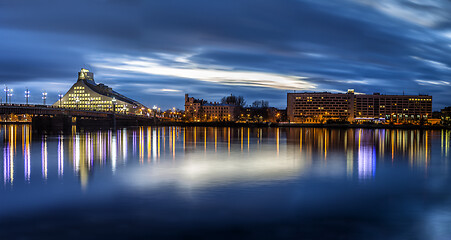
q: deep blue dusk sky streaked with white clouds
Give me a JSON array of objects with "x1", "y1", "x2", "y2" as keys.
[{"x1": 0, "y1": 0, "x2": 451, "y2": 110}]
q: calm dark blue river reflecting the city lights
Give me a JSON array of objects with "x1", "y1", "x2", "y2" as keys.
[{"x1": 0, "y1": 125, "x2": 451, "y2": 239}]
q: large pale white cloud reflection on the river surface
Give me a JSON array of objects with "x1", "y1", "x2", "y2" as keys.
[{"x1": 122, "y1": 146, "x2": 309, "y2": 189}]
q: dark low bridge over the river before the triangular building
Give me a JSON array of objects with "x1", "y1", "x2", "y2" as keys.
[{"x1": 0, "y1": 104, "x2": 159, "y2": 129}]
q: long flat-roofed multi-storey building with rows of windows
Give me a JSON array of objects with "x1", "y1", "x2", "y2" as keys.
[{"x1": 287, "y1": 90, "x2": 432, "y2": 123}]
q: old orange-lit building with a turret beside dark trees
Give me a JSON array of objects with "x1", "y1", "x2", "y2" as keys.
[{"x1": 185, "y1": 94, "x2": 239, "y2": 121}]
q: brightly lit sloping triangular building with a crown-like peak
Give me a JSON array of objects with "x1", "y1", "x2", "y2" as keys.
[{"x1": 52, "y1": 68, "x2": 148, "y2": 115}]
